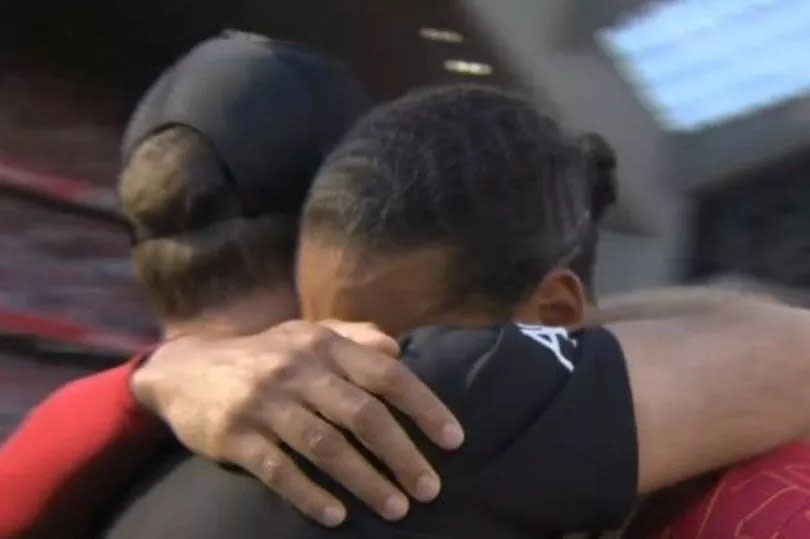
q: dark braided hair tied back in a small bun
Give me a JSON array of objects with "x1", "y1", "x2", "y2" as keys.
[{"x1": 302, "y1": 86, "x2": 616, "y2": 310}]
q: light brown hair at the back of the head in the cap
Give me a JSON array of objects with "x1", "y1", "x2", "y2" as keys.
[{"x1": 118, "y1": 126, "x2": 298, "y2": 320}]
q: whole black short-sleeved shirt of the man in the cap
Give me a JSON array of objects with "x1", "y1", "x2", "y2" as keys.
[{"x1": 105, "y1": 325, "x2": 637, "y2": 539}]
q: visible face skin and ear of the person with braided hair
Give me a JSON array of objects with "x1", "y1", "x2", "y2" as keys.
[{"x1": 296, "y1": 239, "x2": 589, "y2": 344}]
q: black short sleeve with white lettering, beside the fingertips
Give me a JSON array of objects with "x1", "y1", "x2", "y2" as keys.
[{"x1": 400, "y1": 325, "x2": 638, "y2": 530}]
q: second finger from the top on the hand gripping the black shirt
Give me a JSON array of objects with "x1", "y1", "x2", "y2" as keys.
[{"x1": 303, "y1": 376, "x2": 441, "y2": 502}]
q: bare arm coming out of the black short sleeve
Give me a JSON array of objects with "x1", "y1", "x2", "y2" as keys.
[{"x1": 608, "y1": 294, "x2": 810, "y2": 492}]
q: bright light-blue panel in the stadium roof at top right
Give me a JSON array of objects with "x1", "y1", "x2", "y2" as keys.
[{"x1": 597, "y1": 0, "x2": 810, "y2": 131}]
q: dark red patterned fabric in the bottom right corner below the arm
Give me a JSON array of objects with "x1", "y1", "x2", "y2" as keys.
[{"x1": 640, "y1": 443, "x2": 810, "y2": 539}]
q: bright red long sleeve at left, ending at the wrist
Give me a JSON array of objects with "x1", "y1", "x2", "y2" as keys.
[{"x1": 0, "y1": 357, "x2": 171, "y2": 538}]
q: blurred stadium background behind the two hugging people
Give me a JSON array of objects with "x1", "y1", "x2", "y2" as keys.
[{"x1": 0, "y1": 0, "x2": 810, "y2": 439}]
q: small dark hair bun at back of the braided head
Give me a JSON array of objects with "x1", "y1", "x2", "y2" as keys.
[{"x1": 579, "y1": 133, "x2": 618, "y2": 221}]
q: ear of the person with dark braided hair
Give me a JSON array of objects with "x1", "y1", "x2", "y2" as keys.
[{"x1": 513, "y1": 268, "x2": 588, "y2": 327}]
